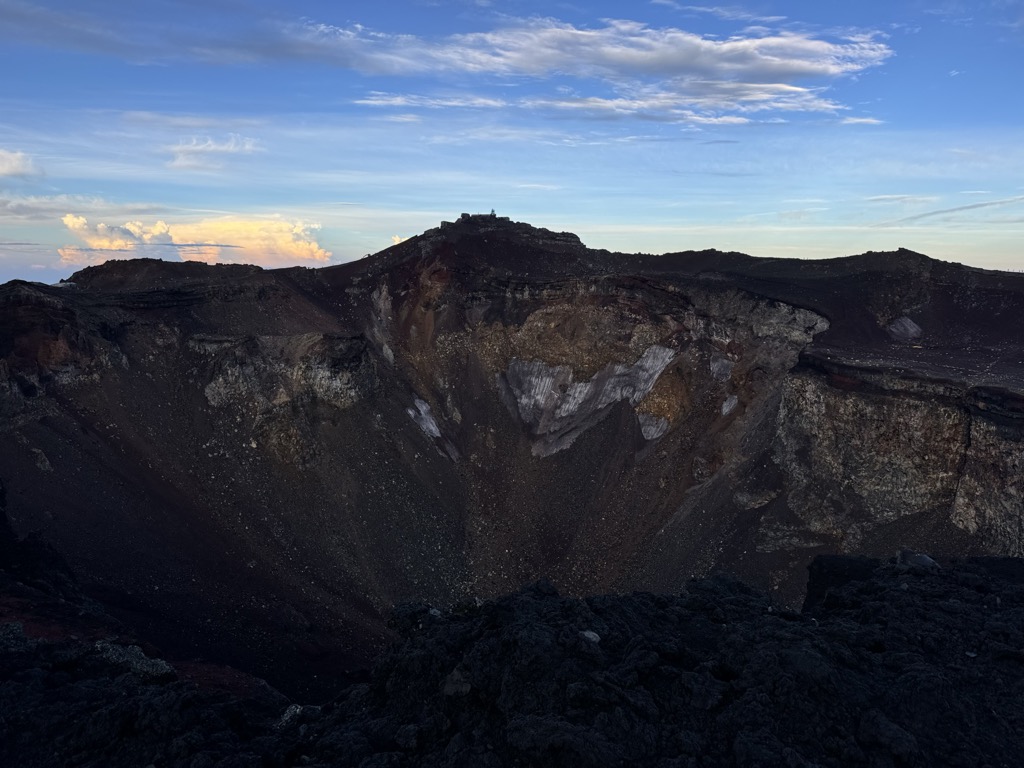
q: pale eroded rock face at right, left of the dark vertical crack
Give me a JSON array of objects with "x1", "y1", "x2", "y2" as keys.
[{"x1": 773, "y1": 374, "x2": 970, "y2": 552}]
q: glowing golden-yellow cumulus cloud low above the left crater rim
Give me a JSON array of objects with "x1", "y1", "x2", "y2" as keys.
[{"x1": 58, "y1": 213, "x2": 331, "y2": 267}]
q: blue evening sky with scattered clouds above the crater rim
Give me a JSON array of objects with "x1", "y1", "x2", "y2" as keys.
[{"x1": 0, "y1": 0, "x2": 1024, "y2": 283}]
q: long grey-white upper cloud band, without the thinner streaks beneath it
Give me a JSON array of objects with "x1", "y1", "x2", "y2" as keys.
[{"x1": 288, "y1": 18, "x2": 891, "y2": 82}]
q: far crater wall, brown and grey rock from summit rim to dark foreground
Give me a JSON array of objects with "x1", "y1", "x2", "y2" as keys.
[{"x1": 0, "y1": 216, "x2": 1024, "y2": 690}]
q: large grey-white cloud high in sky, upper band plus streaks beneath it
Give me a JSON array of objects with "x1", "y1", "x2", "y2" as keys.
[{"x1": 299, "y1": 18, "x2": 892, "y2": 121}]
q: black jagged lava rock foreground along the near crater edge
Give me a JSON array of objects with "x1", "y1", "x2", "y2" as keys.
[{"x1": 0, "y1": 501, "x2": 1024, "y2": 768}]
